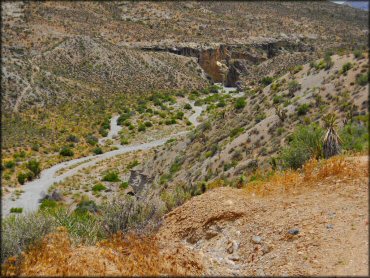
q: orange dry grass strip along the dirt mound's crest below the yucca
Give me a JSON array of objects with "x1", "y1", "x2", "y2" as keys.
[{"x1": 245, "y1": 156, "x2": 368, "y2": 196}]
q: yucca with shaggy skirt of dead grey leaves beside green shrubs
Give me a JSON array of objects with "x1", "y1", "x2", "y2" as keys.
[{"x1": 323, "y1": 113, "x2": 342, "y2": 158}]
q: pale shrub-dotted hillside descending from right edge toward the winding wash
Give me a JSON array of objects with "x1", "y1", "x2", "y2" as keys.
[{"x1": 137, "y1": 52, "x2": 368, "y2": 195}]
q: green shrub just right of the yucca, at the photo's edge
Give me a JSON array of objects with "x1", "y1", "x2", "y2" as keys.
[{"x1": 340, "y1": 122, "x2": 369, "y2": 151}]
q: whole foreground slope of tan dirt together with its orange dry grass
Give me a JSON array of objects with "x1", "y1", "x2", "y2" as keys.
[{"x1": 4, "y1": 157, "x2": 369, "y2": 276}]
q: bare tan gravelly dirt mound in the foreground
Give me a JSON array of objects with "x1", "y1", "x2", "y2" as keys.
[{"x1": 159, "y1": 158, "x2": 368, "y2": 275}]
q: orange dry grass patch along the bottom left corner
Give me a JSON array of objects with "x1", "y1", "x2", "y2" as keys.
[{"x1": 2, "y1": 227, "x2": 202, "y2": 276}]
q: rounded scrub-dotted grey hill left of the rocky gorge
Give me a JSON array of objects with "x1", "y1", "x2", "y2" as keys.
[{"x1": 3, "y1": 36, "x2": 207, "y2": 112}]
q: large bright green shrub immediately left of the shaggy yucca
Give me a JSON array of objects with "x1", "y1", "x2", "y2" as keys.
[{"x1": 279, "y1": 124, "x2": 324, "y2": 169}]
